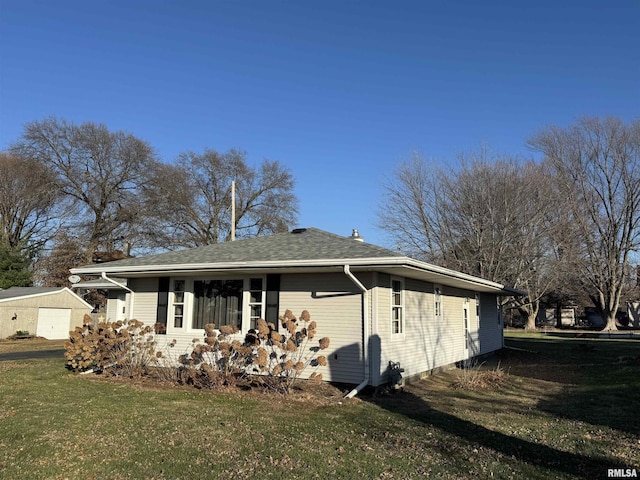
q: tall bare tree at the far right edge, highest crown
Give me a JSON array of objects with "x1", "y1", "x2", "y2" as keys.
[{"x1": 529, "y1": 118, "x2": 640, "y2": 330}]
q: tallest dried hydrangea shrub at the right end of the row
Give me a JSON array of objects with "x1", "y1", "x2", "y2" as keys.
[{"x1": 245, "y1": 310, "x2": 329, "y2": 393}]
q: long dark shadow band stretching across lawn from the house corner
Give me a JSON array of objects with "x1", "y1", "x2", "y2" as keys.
[{"x1": 368, "y1": 392, "x2": 615, "y2": 478}]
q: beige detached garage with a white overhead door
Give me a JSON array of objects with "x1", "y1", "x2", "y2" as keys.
[{"x1": 0, "y1": 287, "x2": 92, "y2": 340}]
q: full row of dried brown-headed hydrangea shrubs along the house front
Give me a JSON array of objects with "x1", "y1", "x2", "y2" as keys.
[{"x1": 65, "y1": 310, "x2": 330, "y2": 393}]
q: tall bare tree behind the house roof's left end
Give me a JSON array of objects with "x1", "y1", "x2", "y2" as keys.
[{"x1": 13, "y1": 118, "x2": 153, "y2": 260}]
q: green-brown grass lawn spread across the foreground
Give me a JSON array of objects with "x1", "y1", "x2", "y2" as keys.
[{"x1": 0, "y1": 333, "x2": 640, "y2": 479}]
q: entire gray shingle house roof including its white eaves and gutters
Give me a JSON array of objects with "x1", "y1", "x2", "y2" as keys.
[{"x1": 71, "y1": 228, "x2": 520, "y2": 295}]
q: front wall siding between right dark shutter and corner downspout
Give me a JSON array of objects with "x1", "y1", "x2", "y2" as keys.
[{"x1": 280, "y1": 273, "x2": 364, "y2": 383}]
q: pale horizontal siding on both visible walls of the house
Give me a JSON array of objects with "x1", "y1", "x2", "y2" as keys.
[{"x1": 100, "y1": 273, "x2": 502, "y2": 386}]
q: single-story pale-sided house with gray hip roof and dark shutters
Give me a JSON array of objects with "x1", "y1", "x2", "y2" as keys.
[{"x1": 72, "y1": 228, "x2": 521, "y2": 388}]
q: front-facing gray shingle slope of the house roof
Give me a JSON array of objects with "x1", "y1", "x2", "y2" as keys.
[{"x1": 81, "y1": 228, "x2": 402, "y2": 268}]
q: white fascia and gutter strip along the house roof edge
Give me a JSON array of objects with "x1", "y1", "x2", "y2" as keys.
[{"x1": 71, "y1": 257, "x2": 524, "y2": 295}]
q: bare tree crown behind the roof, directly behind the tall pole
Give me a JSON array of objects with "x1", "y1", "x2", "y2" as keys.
[{"x1": 144, "y1": 150, "x2": 297, "y2": 248}]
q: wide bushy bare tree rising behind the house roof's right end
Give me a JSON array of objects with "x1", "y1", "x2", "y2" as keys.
[{"x1": 380, "y1": 153, "x2": 556, "y2": 328}]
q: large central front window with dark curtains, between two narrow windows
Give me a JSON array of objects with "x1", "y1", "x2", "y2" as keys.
[{"x1": 191, "y1": 280, "x2": 243, "y2": 329}]
